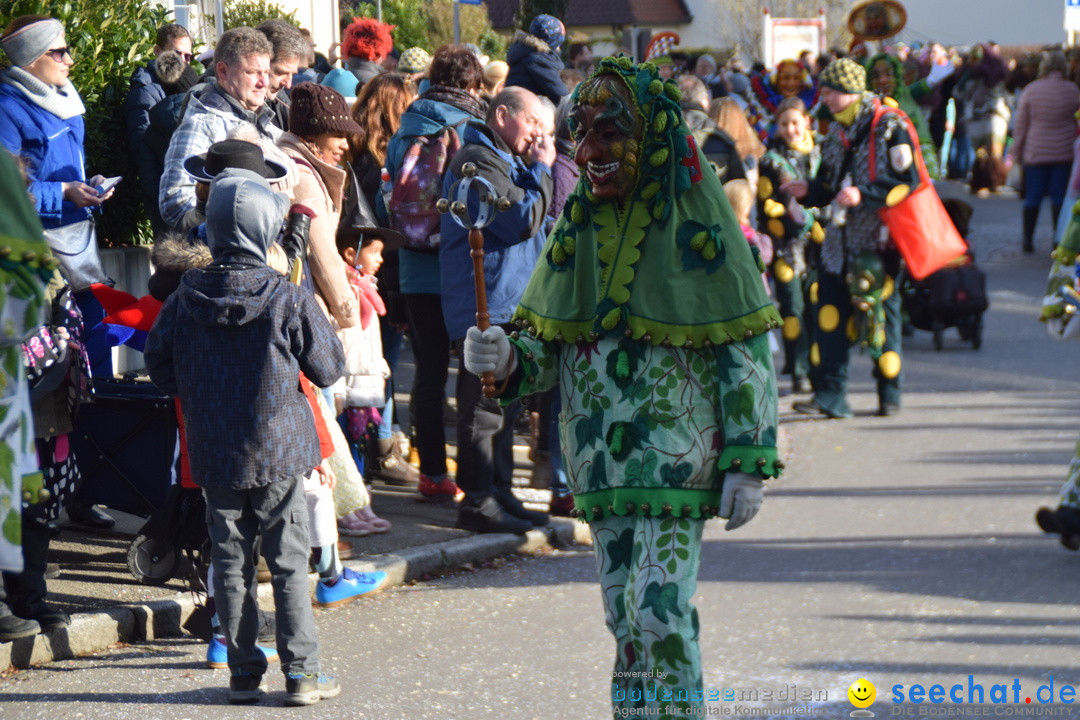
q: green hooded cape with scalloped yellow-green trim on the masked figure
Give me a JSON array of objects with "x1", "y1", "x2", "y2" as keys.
[{"x1": 514, "y1": 57, "x2": 780, "y2": 348}]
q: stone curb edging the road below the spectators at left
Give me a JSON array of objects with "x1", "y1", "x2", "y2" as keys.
[{"x1": 0, "y1": 518, "x2": 591, "y2": 668}]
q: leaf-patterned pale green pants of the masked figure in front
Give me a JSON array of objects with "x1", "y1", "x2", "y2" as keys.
[{"x1": 590, "y1": 515, "x2": 705, "y2": 718}]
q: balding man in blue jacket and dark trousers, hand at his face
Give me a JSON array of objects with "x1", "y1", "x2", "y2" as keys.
[{"x1": 438, "y1": 87, "x2": 555, "y2": 532}]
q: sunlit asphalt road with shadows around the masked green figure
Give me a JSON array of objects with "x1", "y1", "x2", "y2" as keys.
[{"x1": 0, "y1": 186, "x2": 1080, "y2": 720}]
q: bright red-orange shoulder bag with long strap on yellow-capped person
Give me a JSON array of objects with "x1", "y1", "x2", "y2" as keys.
[{"x1": 869, "y1": 100, "x2": 968, "y2": 280}]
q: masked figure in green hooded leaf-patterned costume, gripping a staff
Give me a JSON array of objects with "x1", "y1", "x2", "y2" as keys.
[{"x1": 463, "y1": 57, "x2": 783, "y2": 717}]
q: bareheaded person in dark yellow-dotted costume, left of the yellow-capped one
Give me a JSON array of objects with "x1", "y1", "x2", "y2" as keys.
[{"x1": 757, "y1": 97, "x2": 825, "y2": 393}]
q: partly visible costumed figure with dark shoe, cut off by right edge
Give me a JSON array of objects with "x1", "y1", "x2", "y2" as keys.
[{"x1": 1035, "y1": 201, "x2": 1080, "y2": 551}]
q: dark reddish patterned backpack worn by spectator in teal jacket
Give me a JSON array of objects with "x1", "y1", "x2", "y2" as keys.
[{"x1": 386, "y1": 121, "x2": 467, "y2": 253}]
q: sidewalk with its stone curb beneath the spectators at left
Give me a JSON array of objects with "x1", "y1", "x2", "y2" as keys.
[{"x1": 0, "y1": 474, "x2": 589, "y2": 669}]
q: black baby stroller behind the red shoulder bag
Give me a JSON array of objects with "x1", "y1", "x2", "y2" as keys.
[{"x1": 901, "y1": 199, "x2": 989, "y2": 351}]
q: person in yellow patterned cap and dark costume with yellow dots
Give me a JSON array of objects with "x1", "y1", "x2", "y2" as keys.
[{"x1": 781, "y1": 58, "x2": 919, "y2": 418}]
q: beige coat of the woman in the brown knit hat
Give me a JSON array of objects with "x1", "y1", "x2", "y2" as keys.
[{"x1": 278, "y1": 133, "x2": 360, "y2": 327}]
